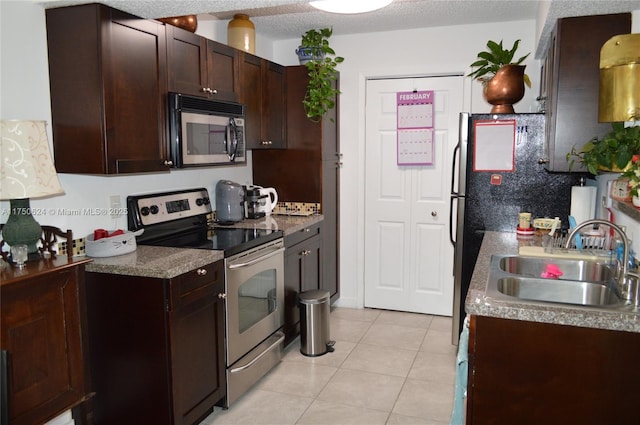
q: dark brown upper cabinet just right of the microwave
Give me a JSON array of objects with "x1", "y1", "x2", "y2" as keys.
[{"x1": 240, "y1": 52, "x2": 287, "y2": 149}]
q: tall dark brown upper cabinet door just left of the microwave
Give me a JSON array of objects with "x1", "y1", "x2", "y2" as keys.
[{"x1": 103, "y1": 11, "x2": 167, "y2": 174}]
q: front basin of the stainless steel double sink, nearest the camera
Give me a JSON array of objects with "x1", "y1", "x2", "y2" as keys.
[{"x1": 497, "y1": 277, "x2": 620, "y2": 306}]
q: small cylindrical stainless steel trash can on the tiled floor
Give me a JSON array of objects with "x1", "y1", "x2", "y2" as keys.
[{"x1": 298, "y1": 290, "x2": 335, "y2": 357}]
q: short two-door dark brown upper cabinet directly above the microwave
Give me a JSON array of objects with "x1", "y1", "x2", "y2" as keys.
[{"x1": 166, "y1": 25, "x2": 240, "y2": 102}]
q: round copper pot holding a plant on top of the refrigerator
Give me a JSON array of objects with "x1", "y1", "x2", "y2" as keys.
[{"x1": 482, "y1": 65, "x2": 525, "y2": 114}]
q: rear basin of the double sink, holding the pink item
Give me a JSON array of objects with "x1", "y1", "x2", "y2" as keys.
[{"x1": 500, "y1": 256, "x2": 613, "y2": 282}]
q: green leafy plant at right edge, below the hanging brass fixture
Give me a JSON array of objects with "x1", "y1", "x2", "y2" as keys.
[{"x1": 567, "y1": 122, "x2": 640, "y2": 176}]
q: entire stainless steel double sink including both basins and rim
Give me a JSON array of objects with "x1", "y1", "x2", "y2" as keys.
[{"x1": 486, "y1": 255, "x2": 624, "y2": 309}]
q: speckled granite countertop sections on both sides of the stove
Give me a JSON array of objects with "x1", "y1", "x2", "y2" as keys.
[{"x1": 86, "y1": 215, "x2": 323, "y2": 279}]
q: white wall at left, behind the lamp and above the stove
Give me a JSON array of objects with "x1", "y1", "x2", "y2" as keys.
[{"x1": 0, "y1": 1, "x2": 255, "y2": 238}]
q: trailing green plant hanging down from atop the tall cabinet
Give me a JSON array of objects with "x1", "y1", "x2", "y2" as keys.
[{"x1": 296, "y1": 28, "x2": 344, "y2": 121}]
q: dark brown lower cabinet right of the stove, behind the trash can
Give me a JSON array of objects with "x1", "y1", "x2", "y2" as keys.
[{"x1": 284, "y1": 223, "x2": 322, "y2": 345}]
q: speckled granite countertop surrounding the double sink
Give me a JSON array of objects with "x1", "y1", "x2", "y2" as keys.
[{"x1": 465, "y1": 232, "x2": 640, "y2": 332}]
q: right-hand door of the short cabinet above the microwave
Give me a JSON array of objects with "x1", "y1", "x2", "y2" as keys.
[{"x1": 207, "y1": 40, "x2": 240, "y2": 102}]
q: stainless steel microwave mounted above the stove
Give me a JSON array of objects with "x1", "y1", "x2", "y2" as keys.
[{"x1": 168, "y1": 93, "x2": 246, "y2": 168}]
